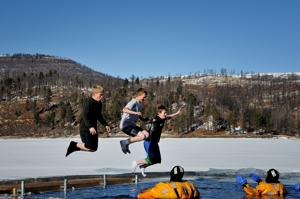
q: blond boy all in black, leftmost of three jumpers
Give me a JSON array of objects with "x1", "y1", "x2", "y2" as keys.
[{"x1": 66, "y1": 85, "x2": 110, "y2": 157}]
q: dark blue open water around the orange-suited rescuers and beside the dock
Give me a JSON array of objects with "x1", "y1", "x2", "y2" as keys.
[{"x1": 0, "y1": 169, "x2": 300, "y2": 199}]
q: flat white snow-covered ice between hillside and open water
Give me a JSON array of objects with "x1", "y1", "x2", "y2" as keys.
[{"x1": 0, "y1": 138, "x2": 300, "y2": 180}]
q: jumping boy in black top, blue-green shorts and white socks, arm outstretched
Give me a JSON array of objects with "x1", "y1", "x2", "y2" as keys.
[{"x1": 132, "y1": 105, "x2": 181, "y2": 177}]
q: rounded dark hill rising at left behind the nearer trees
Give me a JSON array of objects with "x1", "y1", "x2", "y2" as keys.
[{"x1": 0, "y1": 53, "x2": 123, "y2": 94}]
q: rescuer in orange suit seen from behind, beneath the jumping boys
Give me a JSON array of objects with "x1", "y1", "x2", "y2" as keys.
[{"x1": 130, "y1": 166, "x2": 200, "y2": 199}]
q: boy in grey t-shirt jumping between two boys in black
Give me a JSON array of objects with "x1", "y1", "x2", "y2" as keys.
[{"x1": 120, "y1": 88, "x2": 151, "y2": 154}]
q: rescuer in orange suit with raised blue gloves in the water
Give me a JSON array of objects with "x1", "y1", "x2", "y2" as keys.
[{"x1": 236, "y1": 169, "x2": 287, "y2": 197}]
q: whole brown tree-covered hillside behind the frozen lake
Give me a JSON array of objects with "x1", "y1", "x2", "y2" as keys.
[{"x1": 0, "y1": 54, "x2": 300, "y2": 137}]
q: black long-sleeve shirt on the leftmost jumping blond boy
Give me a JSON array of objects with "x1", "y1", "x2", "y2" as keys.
[{"x1": 79, "y1": 97, "x2": 108, "y2": 131}]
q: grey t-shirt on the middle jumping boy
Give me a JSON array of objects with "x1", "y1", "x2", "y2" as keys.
[{"x1": 120, "y1": 98, "x2": 142, "y2": 130}]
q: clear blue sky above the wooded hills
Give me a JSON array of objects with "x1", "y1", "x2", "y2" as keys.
[{"x1": 0, "y1": 0, "x2": 300, "y2": 78}]
